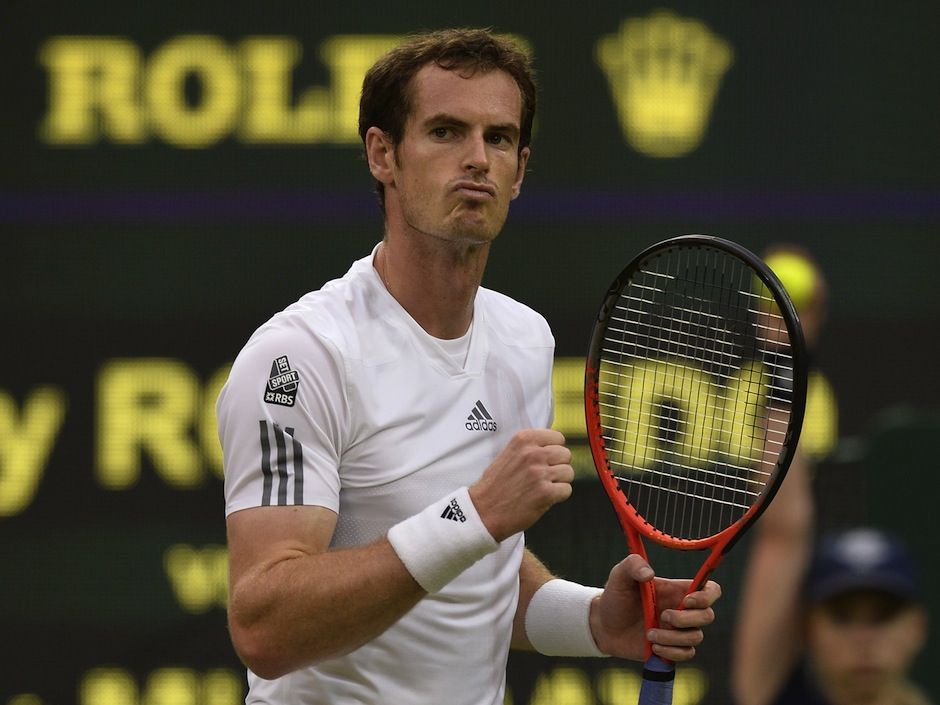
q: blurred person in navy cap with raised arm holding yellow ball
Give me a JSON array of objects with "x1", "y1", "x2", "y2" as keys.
[{"x1": 731, "y1": 247, "x2": 930, "y2": 705}]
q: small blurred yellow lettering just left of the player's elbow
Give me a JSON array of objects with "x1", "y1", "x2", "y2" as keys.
[{"x1": 163, "y1": 544, "x2": 228, "y2": 614}]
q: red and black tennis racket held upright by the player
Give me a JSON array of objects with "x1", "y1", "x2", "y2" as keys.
[{"x1": 584, "y1": 235, "x2": 807, "y2": 705}]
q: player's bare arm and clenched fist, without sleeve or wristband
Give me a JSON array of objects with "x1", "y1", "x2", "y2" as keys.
[{"x1": 227, "y1": 429, "x2": 574, "y2": 679}]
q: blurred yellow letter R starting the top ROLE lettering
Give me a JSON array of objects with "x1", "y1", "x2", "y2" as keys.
[{"x1": 39, "y1": 36, "x2": 146, "y2": 144}]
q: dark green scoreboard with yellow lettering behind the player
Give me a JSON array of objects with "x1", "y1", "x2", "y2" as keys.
[{"x1": 0, "y1": 0, "x2": 940, "y2": 705}]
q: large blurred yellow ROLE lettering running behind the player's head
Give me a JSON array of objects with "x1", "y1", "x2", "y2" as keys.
[{"x1": 39, "y1": 34, "x2": 528, "y2": 149}]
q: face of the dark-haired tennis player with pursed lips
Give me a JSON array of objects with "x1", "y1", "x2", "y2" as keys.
[{"x1": 386, "y1": 64, "x2": 529, "y2": 244}]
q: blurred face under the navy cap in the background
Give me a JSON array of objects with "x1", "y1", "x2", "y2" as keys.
[{"x1": 808, "y1": 591, "x2": 926, "y2": 702}]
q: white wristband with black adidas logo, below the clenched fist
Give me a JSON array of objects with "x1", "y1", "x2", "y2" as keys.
[{"x1": 388, "y1": 487, "x2": 499, "y2": 593}]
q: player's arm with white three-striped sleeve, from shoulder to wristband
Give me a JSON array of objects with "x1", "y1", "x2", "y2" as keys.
[{"x1": 218, "y1": 318, "x2": 425, "y2": 678}]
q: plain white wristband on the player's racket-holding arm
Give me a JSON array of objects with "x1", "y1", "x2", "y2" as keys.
[{"x1": 525, "y1": 578, "x2": 607, "y2": 656}]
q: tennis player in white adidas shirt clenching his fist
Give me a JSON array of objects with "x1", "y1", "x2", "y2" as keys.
[{"x1": 218, "y1": 30, "x2": 720, "y2": 705}]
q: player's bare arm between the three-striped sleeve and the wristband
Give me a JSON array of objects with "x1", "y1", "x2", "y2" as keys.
[{"x1": 227, "y1": 506, "x2": 426, "y2": 678}]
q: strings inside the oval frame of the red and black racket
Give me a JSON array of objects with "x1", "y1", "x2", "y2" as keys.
[{"x1": 598, "y1": 248, "x2": 793, "y2": 539}]
